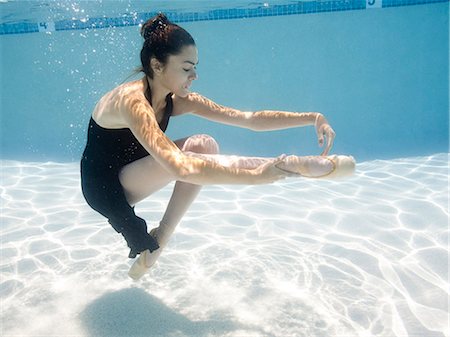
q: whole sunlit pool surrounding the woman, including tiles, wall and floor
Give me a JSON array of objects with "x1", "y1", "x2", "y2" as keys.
[{"x1": 0, "y1": 0, "x2": 450, "y2": 337}]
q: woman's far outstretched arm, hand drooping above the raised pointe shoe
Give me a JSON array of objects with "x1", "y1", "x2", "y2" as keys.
[{"x1": 176, "y1": 93, "x2": 335, "y2": 155}]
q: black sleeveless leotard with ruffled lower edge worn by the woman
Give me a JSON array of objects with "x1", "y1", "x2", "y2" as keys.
[{"x1": 81, "y1": 84, "x2": 173, "y2": 258}]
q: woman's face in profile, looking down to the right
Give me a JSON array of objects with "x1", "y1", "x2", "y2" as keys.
[{"x1": 159, "y1": 45, "x2": 198, "y2": 97}]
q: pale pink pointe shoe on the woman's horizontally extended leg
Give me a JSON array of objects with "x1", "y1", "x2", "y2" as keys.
[{"x1": 276, "y1": 155, "x2": 356, "y2": 179}]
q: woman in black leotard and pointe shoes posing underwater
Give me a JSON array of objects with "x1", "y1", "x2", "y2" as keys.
[{"x1": 81, "y1": 14, "x2": 354, "y2": 276}]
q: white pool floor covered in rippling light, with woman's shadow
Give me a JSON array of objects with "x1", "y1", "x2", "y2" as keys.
[{"x1": 0, "y1": 154, "x2": 450, "y2": 337}]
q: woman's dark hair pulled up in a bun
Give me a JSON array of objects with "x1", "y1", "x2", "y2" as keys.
[{"x1": 140, "y1": 13, "x2": 195, "y2": 78}]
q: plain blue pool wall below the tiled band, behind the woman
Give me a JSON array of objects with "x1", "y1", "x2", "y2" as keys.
[{"x1": 0, "y1": 3, "x2": 449, "y2": 161}]
